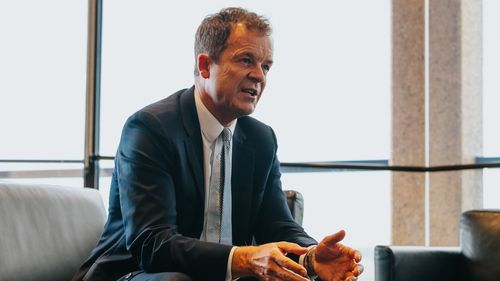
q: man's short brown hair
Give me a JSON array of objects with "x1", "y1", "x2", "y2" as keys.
[{"x1": 194, "y1": 8, "x2": 271, "y2": 76}]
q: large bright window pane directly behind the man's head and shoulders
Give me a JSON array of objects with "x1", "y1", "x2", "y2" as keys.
[{"x1": 101, "y1": 0, "x2": 391, "y2": 161}]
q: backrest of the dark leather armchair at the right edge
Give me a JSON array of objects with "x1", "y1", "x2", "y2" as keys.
[{"x1": 460, "y1": 210, "x2": 500, "y2": 281}]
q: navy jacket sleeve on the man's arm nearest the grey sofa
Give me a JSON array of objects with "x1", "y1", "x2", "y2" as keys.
[{"x1": 116, "y1": 112, "x2": 231, "y2": 280}]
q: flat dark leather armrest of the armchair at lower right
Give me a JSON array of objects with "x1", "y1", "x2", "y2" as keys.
[{"x1": 375, "y1": 246, "x2": 462, "y2": 281}]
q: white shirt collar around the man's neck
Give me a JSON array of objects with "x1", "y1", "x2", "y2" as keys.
[{"x1": 194, "y1": 87, "x2": 238, "y2": 143}]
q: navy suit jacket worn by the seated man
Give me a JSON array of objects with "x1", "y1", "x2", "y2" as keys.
[{"x1": 73, "y1": 88, "x2": 316, "y2": 281}]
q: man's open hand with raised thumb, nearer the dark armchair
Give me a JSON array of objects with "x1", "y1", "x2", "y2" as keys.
[{"x1": 312, "y1": 230, "x2": 363, "y2": 281}]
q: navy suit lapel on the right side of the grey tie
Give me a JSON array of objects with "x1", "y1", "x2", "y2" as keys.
[{"x1": 231, "y1": 124, "x2": 255, "y2": 244}]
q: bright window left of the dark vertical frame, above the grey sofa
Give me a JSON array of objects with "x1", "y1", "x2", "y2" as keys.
[{"x1": 0, "y1": 0, "x2": 87, "y2": 186}]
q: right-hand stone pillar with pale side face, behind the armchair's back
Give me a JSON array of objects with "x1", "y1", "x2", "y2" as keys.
[{"x1": 429, "y1": 0, "x2": 482, "y2": 246}]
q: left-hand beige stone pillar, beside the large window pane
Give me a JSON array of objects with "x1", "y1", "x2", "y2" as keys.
[{"x1": 391, "y1": 0, "x2": 425, "y2": 245}]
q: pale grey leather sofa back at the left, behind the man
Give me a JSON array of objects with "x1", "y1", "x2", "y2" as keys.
[{"x1": 0, "y1": 182, "x2": 106, "y2": 281}]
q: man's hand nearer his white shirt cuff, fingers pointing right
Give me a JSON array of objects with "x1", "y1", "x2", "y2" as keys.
[{"x1": 231, "y1": 242, "x2": 309, "y2": 281}]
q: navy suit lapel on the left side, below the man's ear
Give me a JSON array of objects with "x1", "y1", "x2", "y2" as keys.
[{"x1": 180, "y1": 86, "x2": 205, "y2": 202}]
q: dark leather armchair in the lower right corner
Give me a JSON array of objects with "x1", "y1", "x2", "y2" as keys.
[{"x1": 375, "y1": 210, "x2": 500, "y2": 281}]
